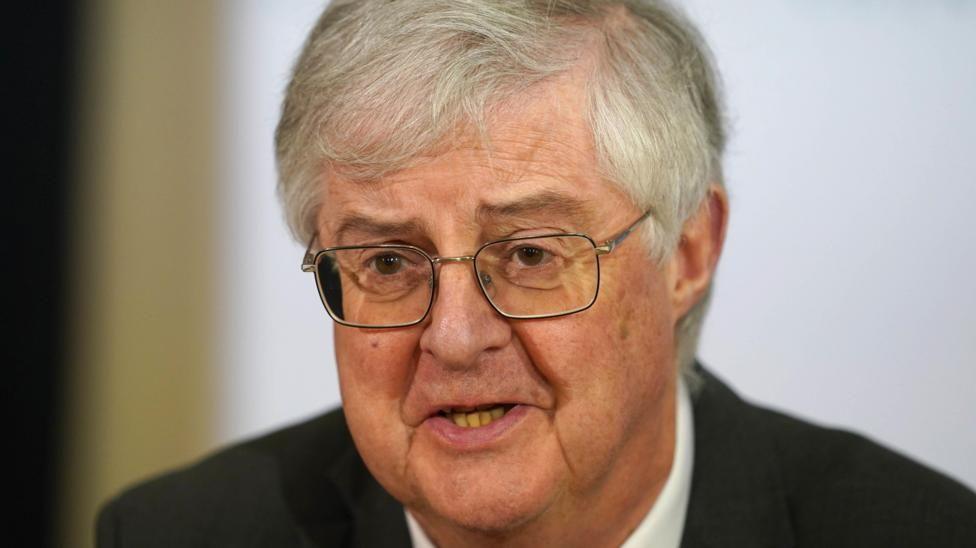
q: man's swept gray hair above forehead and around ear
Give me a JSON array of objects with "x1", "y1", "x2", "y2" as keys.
[{"x1": 276, "y1": 0, "x2": 725, "y2": 380}]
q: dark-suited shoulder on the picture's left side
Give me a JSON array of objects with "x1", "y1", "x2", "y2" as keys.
[{"x1": 96, "y1": 410, "x2": 358, "y2": 546}]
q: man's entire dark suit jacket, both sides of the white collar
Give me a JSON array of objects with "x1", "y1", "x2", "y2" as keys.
[{"x1": 97, "y1": 371, "x2": 976, "y2": 548}]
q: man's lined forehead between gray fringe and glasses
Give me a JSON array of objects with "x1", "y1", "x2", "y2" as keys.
[{"x1": 319, "y1": 76, "x2": 622, "y2": 240}]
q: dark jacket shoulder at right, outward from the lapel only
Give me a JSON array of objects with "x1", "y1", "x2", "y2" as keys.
[{"x1": 756, "y1": 408, "x2": 976, "y2": 546}]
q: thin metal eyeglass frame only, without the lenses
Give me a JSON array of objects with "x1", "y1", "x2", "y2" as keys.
[{"x1": 302, "y1": 210, "x2": 651, "y2": 329}]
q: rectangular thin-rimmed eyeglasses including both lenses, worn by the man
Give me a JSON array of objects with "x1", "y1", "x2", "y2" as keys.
[{"x1": 302, "y1": 211, "x2": 651, "y2": 328}]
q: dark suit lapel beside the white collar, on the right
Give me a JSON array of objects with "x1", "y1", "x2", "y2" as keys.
[{"x1": 681, "y1": 367, "x2": 794, "y2": 548}]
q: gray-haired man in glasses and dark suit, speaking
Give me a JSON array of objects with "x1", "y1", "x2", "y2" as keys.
[{"x1": 98, "y1": 0, "x2": 976, "y2": 547}]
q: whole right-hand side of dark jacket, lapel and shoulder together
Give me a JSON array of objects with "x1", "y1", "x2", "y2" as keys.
[{"x1": 689, "y1": 372, "x2": 976, "y2": 546}]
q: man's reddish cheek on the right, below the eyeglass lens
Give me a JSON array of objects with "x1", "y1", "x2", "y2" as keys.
[{"x1": 515, "y1": 264, "x2": 674, "y2": 482}]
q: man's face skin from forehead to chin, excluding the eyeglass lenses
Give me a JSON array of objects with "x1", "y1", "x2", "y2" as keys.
[{"x1": 319, "y1": 77, "x2": 675, "y2": 531}]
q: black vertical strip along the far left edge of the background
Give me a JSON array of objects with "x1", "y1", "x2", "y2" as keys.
[{"x1": 0, "y1": 1, "x2": 80, "y2": 546}]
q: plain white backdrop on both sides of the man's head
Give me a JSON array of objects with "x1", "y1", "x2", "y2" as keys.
[{"x1": 215, "y1": 0, "x2": 976, "y2": 487}]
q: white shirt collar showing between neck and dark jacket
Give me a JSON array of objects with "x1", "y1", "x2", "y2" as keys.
[{"x1": 403, "y1": 381, "x2": 695, "y2": 548}]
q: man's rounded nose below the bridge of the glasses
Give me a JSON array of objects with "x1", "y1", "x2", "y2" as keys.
[{"x1": 420, "y1": 261, "x2": 512, "y2": 369}]
